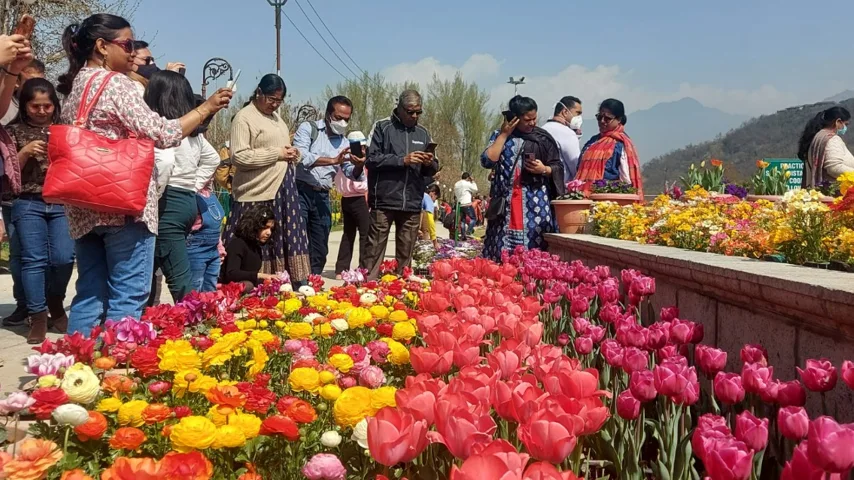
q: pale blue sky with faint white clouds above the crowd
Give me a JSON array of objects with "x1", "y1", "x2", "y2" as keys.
[{"x1": 133, "y1": 0, "x2": 854, "y2": 115}]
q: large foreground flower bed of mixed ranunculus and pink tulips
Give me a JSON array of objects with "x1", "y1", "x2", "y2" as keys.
[{"x1": 0, "y1": 250, "x2": 854, "y2": 480}]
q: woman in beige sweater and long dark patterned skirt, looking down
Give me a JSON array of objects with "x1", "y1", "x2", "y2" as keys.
[{"x1": 223, "y1": 73, "x2": 311, "y2": 284}]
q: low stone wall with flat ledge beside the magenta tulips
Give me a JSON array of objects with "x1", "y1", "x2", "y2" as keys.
[{"x1": 547, "y1": 234, "x2": 854, "y2": 422}]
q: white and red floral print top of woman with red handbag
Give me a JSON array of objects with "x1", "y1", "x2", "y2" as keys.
[{"x1": 62, "y1": 67, "x2": 183, "y2": 240}]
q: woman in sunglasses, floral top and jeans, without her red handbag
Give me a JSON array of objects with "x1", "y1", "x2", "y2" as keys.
[{"x1": 57, "y1": 14, "x2": 232, "y2": 335}]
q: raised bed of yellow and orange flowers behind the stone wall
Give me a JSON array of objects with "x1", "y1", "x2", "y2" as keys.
[{"x1": 591, "y1": 188, "x2": 854, "y2": 267}]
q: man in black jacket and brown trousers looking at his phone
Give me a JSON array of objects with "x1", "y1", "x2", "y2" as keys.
[{"x1": 365, "y1": 90, "x2": 439, "y2": 279}]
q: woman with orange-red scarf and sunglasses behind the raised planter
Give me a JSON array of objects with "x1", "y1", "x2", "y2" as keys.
[{"x1": 575, "y1": 98, "x2": 643, "y2": 197}]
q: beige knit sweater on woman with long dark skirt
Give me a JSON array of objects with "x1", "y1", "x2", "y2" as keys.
[{"x1": 231, "y1": 103, "x2": 291, "y2": 202}]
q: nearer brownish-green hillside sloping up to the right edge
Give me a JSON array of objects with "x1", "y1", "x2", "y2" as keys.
[{"x1": 640, "y1": 98, "x2": 854, "y2": 193}]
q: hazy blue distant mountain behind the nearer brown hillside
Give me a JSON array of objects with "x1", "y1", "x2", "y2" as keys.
[{"x1": 626, "y1": 98, "x2": 748, "y2": 163}]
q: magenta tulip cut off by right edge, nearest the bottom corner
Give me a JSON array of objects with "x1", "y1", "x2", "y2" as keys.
[{"x1": 807, "y1": 417, "x2": 854, "y2": 473}]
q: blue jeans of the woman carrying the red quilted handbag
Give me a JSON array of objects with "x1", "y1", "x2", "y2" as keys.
[{"x1": 68, "y1": 219, "x2": 155, "y2": 336}]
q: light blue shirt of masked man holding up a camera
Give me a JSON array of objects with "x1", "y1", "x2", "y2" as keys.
[{"x1": 294, "y1": 120, "x2": 365, "y2": 190}]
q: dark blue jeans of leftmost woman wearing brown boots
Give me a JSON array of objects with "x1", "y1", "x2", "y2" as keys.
[{"x1": 12, "y1": 196, "x2": 74, "y2": 314}]
